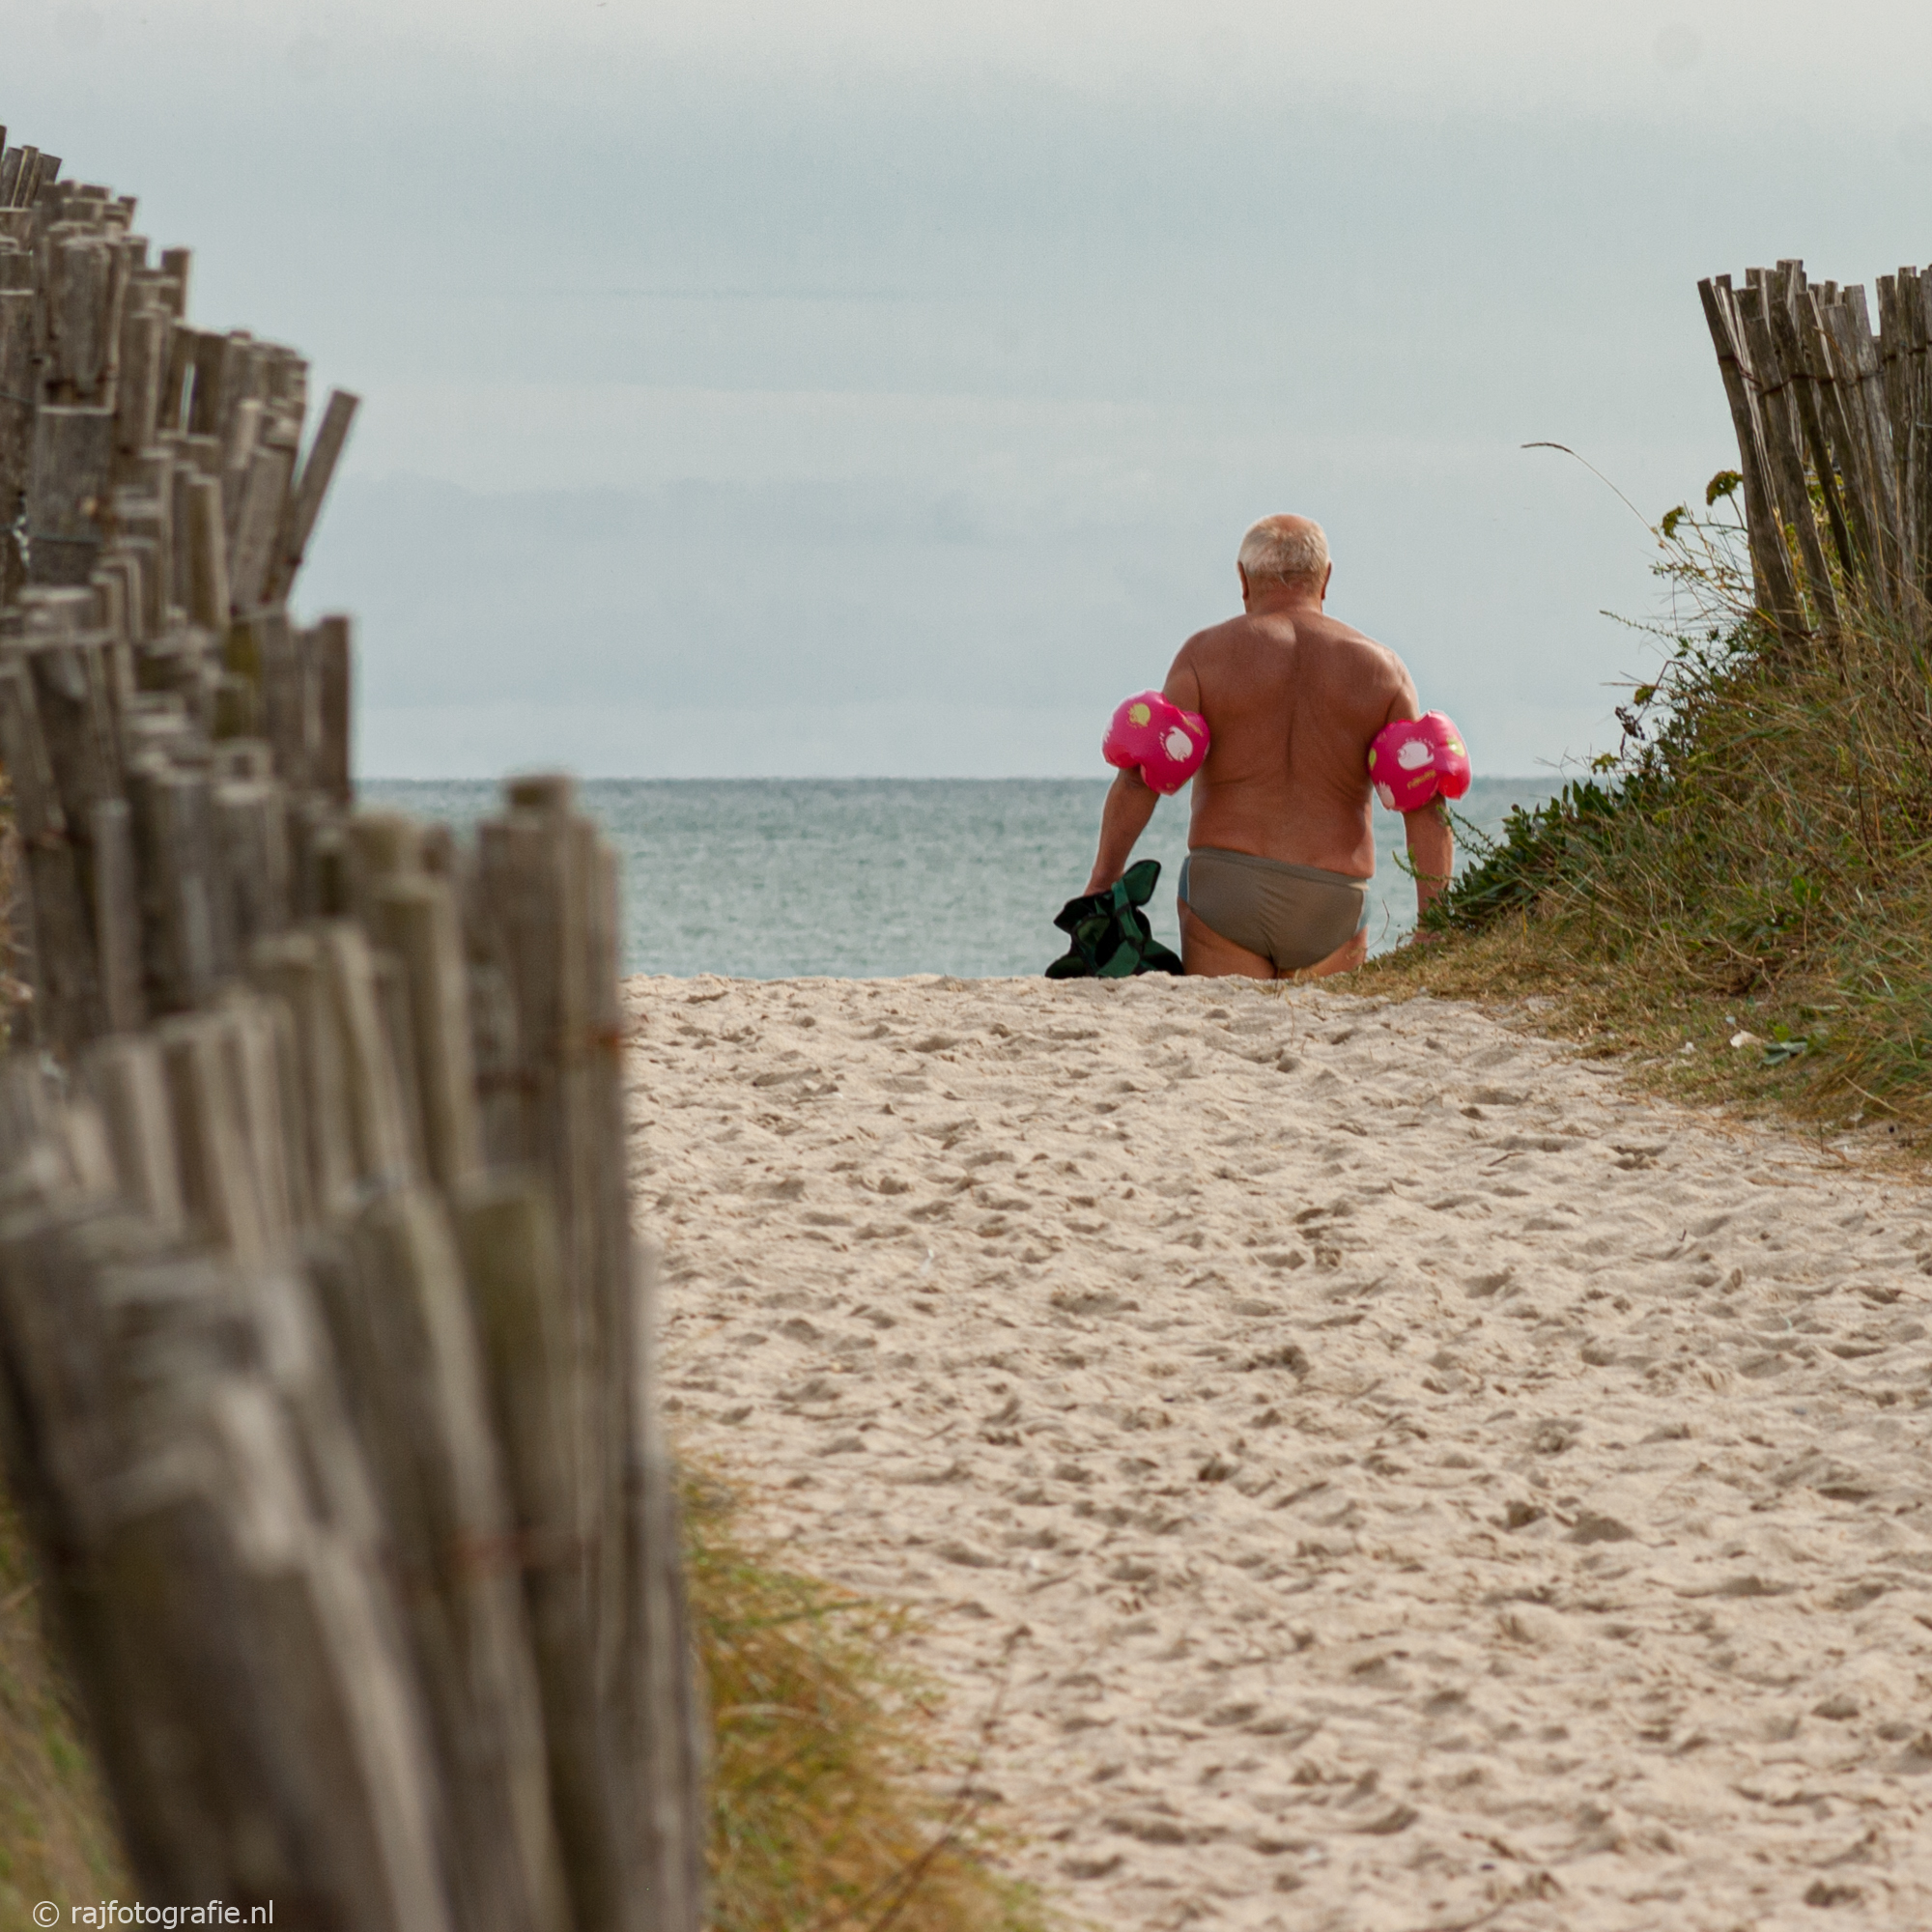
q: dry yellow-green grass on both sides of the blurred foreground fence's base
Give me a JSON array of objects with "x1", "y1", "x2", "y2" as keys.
[{"x1": 0, "y1": 1480, "x2": 1049, "y2": 1932}]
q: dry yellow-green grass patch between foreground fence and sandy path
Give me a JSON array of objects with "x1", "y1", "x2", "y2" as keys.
[{"x1": 686, "y1": 1478, "x2": 1049, "y2": 1932}]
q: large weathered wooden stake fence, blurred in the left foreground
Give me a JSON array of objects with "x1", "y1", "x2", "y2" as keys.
[{"x1": 0, "y1": 125, "x2": 703, "y2": 1932}]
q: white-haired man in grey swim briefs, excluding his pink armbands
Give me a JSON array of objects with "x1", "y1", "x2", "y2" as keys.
[{"x1": 1088, "y1": 516, "x2": 1455, "y2": 980}]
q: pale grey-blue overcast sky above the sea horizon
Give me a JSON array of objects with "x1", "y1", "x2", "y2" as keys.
[{"x1": 14, "y1": 0, "x2": 1932, "y2": 777}]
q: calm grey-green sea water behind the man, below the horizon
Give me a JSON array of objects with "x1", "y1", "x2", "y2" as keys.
[{"x1": 359, "y1": 779, "x2": 1555, "y2": 980}]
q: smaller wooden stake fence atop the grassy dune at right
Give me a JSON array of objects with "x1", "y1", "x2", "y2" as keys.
[{"x1": 1698, "y1": 261, "x2": 1932, "y2": 639}]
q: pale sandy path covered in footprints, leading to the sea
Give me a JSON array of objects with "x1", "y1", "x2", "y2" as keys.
[{"x1": 628, "y1": 980, "x2": 1932, "y2": 1932}]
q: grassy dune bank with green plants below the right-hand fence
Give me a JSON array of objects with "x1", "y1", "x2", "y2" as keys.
[{"x1": 1370, "y1": 477, "x2": 1932, "y2": 1134}]
